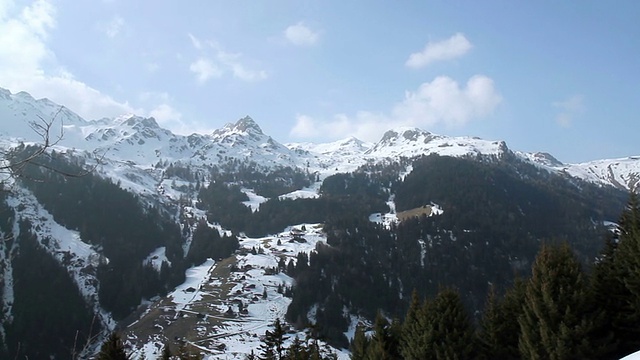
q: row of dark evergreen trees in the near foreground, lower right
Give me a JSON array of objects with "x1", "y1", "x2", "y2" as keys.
[{"x1": 350, "y1": 194, "x2": 640, "y2": 360}]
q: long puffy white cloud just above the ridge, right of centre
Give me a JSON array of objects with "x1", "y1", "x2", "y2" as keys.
[{"x1": 290, "y1": 75, "x2": 502, "y2": 141}]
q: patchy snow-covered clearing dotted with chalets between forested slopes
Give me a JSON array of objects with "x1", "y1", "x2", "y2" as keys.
[{"x1": 125, "y1": 224, "x2": 348, "y2": 360}]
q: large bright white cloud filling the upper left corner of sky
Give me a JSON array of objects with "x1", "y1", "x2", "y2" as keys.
[{"x1": 0, "y1": 0, "x2": 138, "y2": 119}]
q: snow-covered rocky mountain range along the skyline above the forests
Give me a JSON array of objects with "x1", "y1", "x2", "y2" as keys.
[{"x1": 0, "y1": 89, "x2": 640, "y2": 193}]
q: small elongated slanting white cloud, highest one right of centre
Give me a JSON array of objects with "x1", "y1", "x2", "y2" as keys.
[{"x1": 405, "y1": 33, "x2": 473, "y2": 68}]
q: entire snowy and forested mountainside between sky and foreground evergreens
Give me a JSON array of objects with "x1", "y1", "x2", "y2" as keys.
[{"x1": 0, "y1": 90, "x2": 640, "y2": 359}]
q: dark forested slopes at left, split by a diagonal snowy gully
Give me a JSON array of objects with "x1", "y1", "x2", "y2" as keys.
[{"x1": 0, "y1": 147, "x2": 238, "y2": 358}]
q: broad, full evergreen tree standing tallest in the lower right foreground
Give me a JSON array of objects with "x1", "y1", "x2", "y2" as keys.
[{"x1": 518, "y1": 244, "x2": 604, "y2": 360}]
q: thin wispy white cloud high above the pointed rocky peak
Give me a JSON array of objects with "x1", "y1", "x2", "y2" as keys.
[{"x1": 188, "y1": 34, "x2": 268, "y2": 83}]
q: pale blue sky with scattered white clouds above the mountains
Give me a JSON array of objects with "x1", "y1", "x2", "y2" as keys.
[{"x1": 0, "y1": 0, "x2": 640, "y2": 163}]
